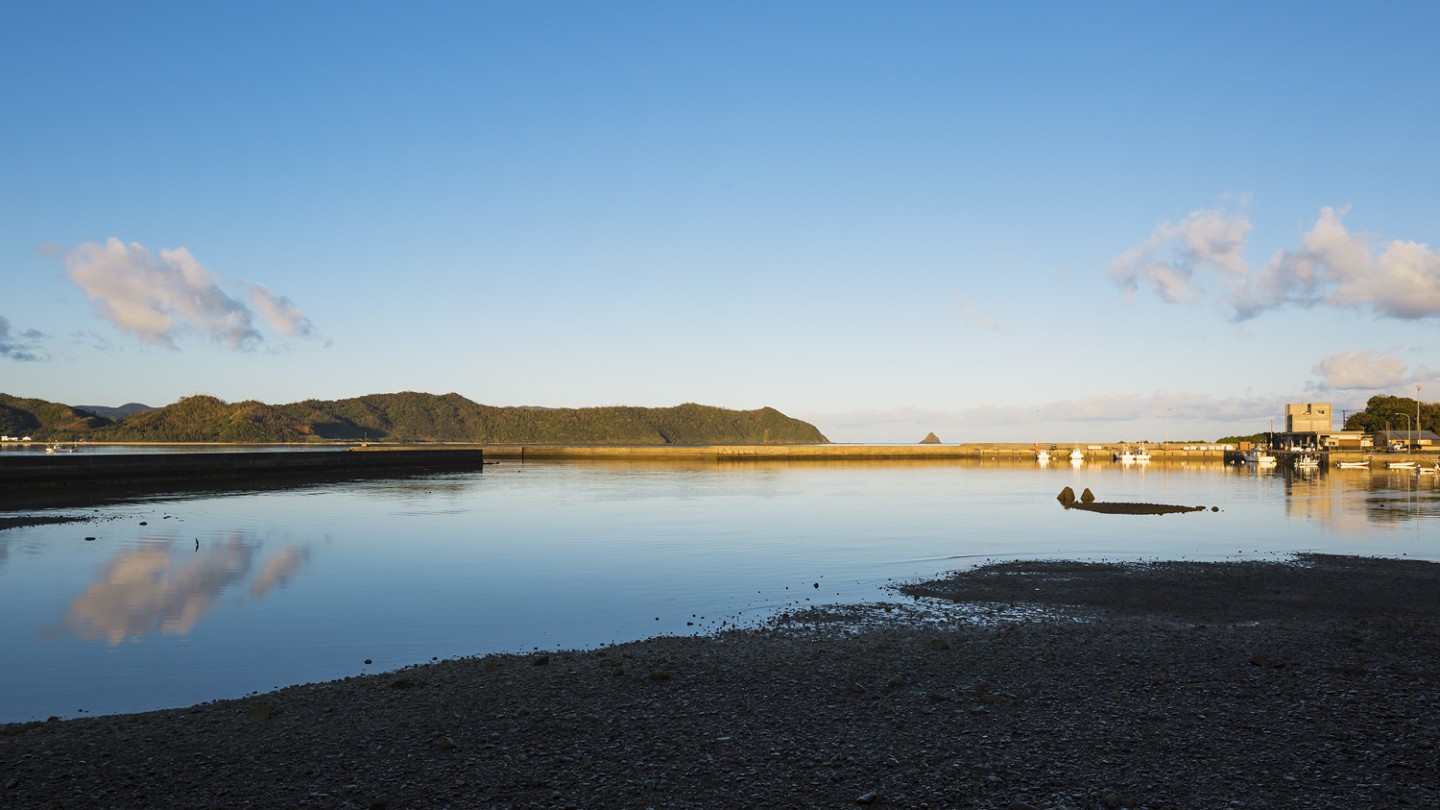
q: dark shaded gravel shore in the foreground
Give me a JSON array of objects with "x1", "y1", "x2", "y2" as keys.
[{"x1": 0, "y1": 556, "x2": 1440, "y2": 810}]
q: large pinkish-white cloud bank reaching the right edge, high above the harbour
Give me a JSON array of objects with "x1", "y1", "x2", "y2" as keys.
[{"x1": 1110, "y1": 208, "x2": 1440, "y2": 320}]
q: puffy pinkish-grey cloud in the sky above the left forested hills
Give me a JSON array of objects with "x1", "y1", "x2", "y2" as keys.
[{"x1": 65, "y1": 236, "x2": 312, "y2": 349}]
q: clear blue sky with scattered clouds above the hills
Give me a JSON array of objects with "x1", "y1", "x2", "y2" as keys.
[{"x1": 0, "y1": 1, "x2": 1440, "y2": 442}]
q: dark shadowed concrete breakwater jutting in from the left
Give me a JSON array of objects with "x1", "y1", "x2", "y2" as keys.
[{"x1": 0, "y1": 447, "x2": 485, "y2": 507}]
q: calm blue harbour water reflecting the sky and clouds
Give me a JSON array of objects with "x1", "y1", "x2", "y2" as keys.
[{"x1": 0, "y1": 463, "x2": 1440, "y2": 722}]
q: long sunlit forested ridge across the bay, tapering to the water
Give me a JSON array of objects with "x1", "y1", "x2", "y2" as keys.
[{"x1": 0, "y1": 392, "x2": 828, "y2": 444}]
